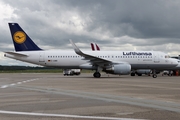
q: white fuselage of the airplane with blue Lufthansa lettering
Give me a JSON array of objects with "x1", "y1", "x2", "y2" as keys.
[{"x1": 5, "y1": 50, "x2": 178, "y2": 70}]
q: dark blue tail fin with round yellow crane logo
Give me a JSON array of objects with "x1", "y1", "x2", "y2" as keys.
[{"x1": 9, "y1": 23, "x2": 42, "y2": 51}]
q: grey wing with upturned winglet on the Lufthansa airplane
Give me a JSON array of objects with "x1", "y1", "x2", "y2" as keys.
[{"x1": 70, "y1": 40, "x2": 125, "y2": 67}]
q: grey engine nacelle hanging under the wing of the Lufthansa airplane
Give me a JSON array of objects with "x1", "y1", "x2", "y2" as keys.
[{"x1": 103, "y1": 63, "x2": 131, "y2": 75}]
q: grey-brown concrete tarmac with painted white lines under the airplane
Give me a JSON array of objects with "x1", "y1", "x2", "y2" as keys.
[{"x1": 0, "y1": 73, "x2": 180, "y2": 120}]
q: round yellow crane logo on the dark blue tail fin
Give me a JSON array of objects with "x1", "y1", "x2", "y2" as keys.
[{"x1": 13, "y1": 31, "x2": 26, "y2": 44}]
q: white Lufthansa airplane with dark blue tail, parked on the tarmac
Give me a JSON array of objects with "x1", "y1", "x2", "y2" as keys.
[{"x1": 4, "y1": 23, "x2": 178, "y2": 78}]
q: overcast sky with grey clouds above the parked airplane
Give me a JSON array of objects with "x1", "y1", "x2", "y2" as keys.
[{"x1": 0, "y1": 0, "x2": 180, "y2": 65}]
